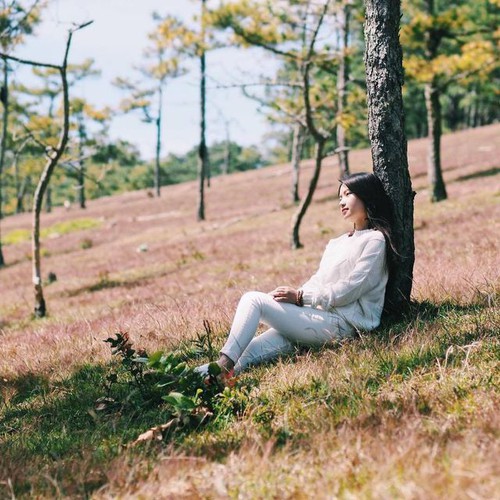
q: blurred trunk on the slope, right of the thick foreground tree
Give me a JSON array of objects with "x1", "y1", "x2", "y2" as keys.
[{"x1": 425, "y1": 83, "x2": 447, "y2": 202}]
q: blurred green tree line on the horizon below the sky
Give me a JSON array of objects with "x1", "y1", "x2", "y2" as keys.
[{"x1": 3, "y1": 140, "x2": 269, "y2": 215}]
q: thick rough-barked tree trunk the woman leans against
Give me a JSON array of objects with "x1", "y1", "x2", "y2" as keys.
[{"x1": 365, "y1": 0, "x2": 415, "y2": 312}]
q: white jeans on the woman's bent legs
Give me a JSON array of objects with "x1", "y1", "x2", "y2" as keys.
[{"x1": 221, "y1": 292, "x2": 354, "y2": 373}]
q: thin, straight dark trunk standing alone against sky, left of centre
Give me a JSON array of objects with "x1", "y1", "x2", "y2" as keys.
[{"x1": 198, "y1": 0, "x2": 210, "y2": 221}]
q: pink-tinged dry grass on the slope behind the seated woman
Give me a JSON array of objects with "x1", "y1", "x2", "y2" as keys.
[{"x1": 0, "y1": 125, "x2": 500, "y2": 376}]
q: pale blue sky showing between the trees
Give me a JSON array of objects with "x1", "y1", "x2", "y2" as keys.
[{"x1": 15, "y1": 0, "x2": 274, "y2": 158}]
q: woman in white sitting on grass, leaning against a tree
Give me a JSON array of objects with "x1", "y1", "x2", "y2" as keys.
[{"x1": 196, "y1": 173, "x2": 394, "y2": 377}]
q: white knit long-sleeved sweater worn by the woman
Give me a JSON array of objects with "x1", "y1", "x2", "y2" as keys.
[{"x1": 301, "y1": 229, "x2": 388, "y2": 330}]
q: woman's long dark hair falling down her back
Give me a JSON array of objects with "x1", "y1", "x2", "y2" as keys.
[{"x1": 339, "y1": 172, "x2": 398, "y2": 272}]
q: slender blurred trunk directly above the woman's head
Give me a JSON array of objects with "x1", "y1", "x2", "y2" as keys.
[{"x1": 337, "y1": 0, "x2": 350, "y2": 179}]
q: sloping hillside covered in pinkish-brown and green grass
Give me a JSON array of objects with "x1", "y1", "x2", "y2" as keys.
[{"x1": 0, "y1": 125, "x2": 500, "y2": 498}]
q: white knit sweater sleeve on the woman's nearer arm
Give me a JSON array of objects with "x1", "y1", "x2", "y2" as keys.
[{"x1": 303, "y1": 239, "x2": 385, "y2": 310}]
